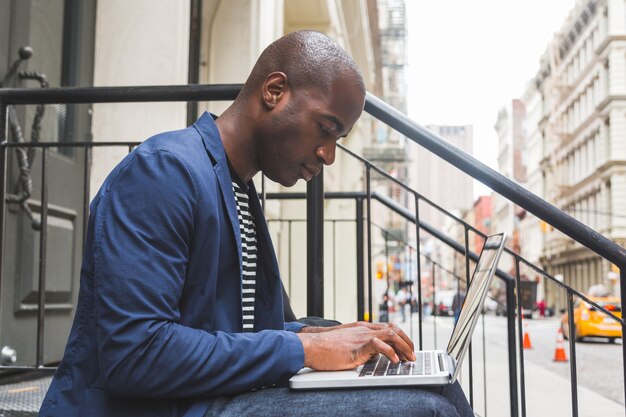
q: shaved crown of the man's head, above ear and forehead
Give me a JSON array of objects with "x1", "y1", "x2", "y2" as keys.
[{"x1": 241, "y1": 30, "x2": 365, "y2": 98}]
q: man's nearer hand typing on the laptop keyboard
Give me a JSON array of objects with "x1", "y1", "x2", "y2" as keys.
[{"x1": 298, "y1": 322, "x2": 415, "y2": 371}]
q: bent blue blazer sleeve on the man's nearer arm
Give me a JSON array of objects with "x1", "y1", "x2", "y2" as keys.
[{"x1": 92, "y1": 150, "x2": 304, "y2": 398}]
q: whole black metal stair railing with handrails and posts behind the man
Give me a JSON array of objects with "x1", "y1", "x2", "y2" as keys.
[{"x1": 0, "y1": 85, "x2": 626, "y2": 416}]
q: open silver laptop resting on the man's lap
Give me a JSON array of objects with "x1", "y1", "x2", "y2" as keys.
[{"x1": 289, "y1": 233, "x2": 506, "y2": 389}]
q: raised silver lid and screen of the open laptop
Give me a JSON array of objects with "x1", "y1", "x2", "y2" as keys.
[{"x1": 447, "y1": 233, "x2": 506, "y2": 377}]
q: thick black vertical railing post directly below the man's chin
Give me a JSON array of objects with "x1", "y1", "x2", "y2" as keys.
[{"x1": 306, "y1": 170, "x2": 324, "y2": 317}]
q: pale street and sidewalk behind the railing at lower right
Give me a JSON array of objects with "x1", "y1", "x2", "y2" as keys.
[{"x1": 392, "y1": 314, "x2": 625, "y2": 417}]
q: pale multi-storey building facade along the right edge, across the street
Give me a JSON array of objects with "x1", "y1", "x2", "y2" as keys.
[{"x1": 527, "y1": 0, "x2": 626, "y2": 306}]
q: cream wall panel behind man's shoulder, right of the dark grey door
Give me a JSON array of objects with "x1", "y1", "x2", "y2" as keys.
[{"x1": 91, "y1": 0, "x2": 190, "y2": 197}]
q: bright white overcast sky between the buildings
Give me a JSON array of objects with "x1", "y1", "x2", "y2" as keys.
[{"x1": 406, "y1": 0, "x2": 576, "y2": 197}]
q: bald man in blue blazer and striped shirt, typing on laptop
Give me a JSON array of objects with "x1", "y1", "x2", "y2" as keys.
[{"x1": 40, "y1": 31, "x2": 471, "y2": 416}]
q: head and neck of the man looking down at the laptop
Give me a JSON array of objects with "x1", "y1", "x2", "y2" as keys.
[{"x1": 215, "y1": 31, "x2": 365, "y2": 187}]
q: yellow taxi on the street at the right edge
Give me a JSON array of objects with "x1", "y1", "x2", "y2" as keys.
[{"x1": 561, "y1": 296, "x2": 622, "y2": 343}]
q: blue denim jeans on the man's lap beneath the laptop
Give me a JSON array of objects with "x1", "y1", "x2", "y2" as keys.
[{"x1": 206, "y1": 382, "x2": 474, "y2": 417}]
